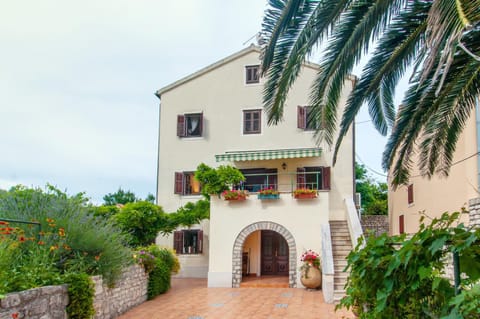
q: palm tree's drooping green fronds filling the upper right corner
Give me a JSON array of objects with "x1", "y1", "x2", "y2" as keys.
[{"x1": 262, "y1": 0, "x2": 480, "y2": 186}]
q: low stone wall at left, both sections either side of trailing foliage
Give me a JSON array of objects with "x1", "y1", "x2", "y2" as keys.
[{"x1": 0, "y1": 265, "x2": 148, "y2": 319}]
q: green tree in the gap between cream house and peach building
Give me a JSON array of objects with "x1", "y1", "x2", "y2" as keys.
[{"x1": 355, "y1": 163, "x2": 388, "y2": 215}]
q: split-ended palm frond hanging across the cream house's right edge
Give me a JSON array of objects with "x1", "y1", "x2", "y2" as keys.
[{"x1": 333, "y1": 1, "x2": 431, "y2": 163}]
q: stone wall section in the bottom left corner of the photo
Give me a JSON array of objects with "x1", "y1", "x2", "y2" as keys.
[{"x1": 0, "y1": 285, "x2": 68, "y2": 319}]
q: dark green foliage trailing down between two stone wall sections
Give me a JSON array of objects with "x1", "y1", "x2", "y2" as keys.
[{"x1": 64, "y1": 273, "x2": 95, "y2": 319}]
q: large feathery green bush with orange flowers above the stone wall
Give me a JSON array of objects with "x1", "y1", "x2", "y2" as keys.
[{"x1": 0, "y1": 186, "x2": 131, "y2": 288}]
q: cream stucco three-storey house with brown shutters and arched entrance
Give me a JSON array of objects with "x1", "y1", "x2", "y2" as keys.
[{"x1": 156, "y1": 45, "x2": 361, "y2": 301}]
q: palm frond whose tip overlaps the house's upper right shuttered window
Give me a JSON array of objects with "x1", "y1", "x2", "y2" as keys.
[{"x1": 311, "y1": 0, "x2": 405, "y2": 145}]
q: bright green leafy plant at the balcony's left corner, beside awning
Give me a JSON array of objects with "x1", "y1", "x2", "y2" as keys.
[{"x1": 195, "y1": 163, "x2": 245, "y2": 198}]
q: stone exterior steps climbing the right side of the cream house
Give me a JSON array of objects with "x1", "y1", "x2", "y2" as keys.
[{"x1": 330, "y1": 220, "x2": 352, "y2": 303}]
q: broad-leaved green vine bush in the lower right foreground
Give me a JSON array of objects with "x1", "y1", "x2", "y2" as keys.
[{"x1": 340, "y1": 213, "x2": 480, "y2": 318}]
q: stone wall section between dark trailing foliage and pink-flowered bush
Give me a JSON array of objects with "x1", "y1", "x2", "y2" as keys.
[{"x1": 92, "y1": 265, "x2": 148, "y2": 319}]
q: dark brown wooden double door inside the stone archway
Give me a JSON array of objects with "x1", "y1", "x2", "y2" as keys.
[{"x1": 261, "y1": 230, "x2": 289, "y2": 276}]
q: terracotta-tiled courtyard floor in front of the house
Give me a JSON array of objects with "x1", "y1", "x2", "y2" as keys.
[{"x1": 119, "y1": 279, "x2": 355, "y2": 319}]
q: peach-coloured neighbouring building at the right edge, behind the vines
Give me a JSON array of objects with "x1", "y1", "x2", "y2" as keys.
[{"x1": 388, "y1": 107, "x2": 480, "y2": 235}]
